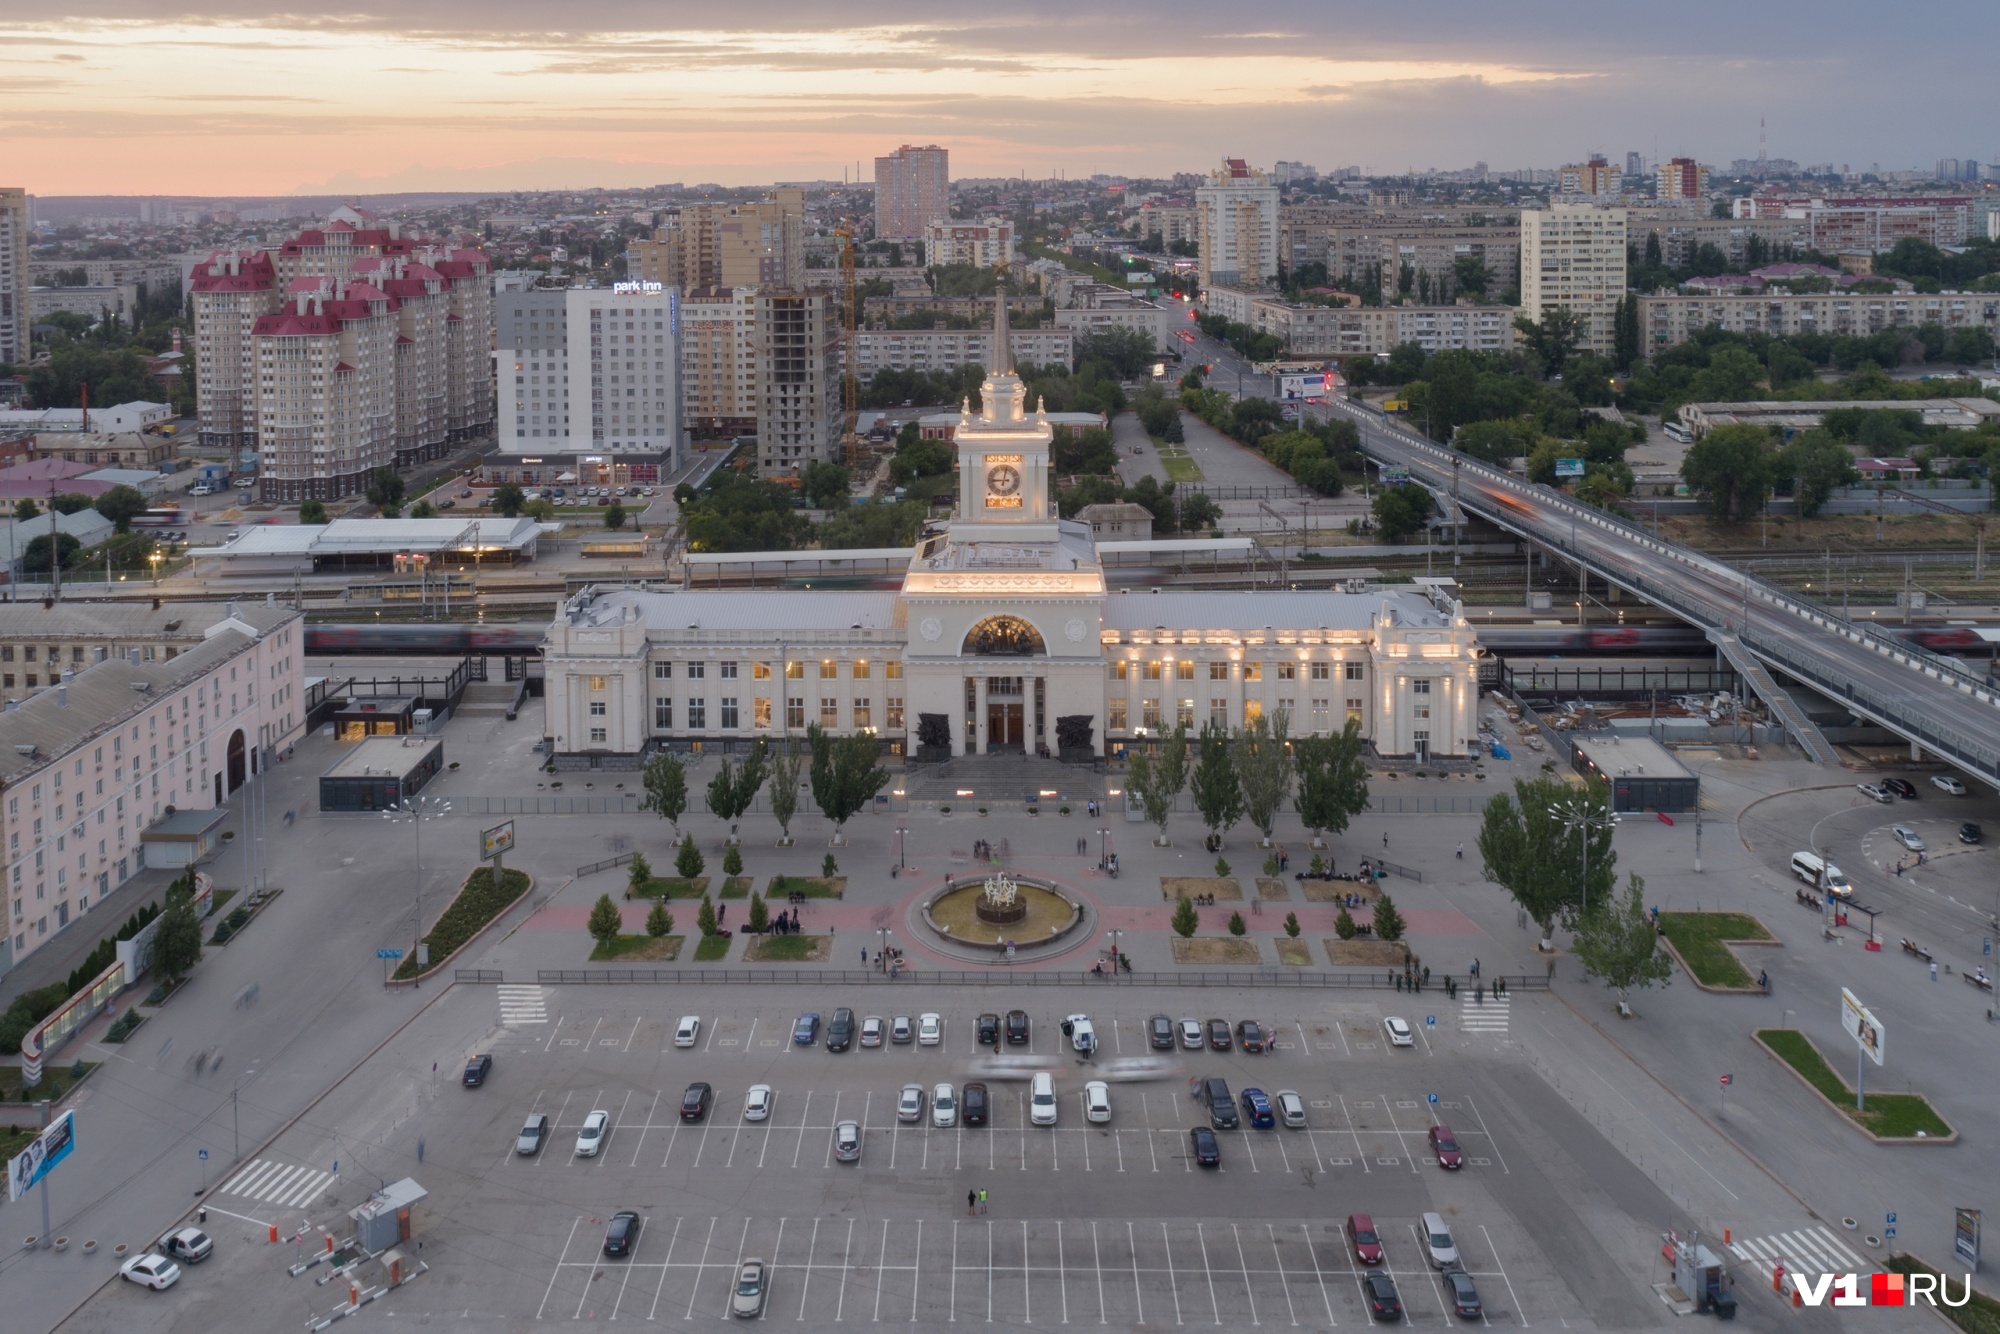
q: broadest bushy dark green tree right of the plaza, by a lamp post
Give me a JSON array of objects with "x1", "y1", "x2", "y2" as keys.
[{"x1": 1480, "y1": 778, "x2": 1618, "y2": 950}]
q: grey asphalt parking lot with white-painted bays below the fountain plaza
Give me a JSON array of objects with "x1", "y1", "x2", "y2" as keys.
[{"x1": 62, "y1": 986, "x2": 1680, "y2": 1330}]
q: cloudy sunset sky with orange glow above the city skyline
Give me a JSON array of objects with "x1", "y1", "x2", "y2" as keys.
[{"x1": 0, "y1": 0, "x2": 2000, "y2": 194}]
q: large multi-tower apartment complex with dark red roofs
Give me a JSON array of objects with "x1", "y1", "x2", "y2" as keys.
[{"x1": 194, "y1": 208, "x2": 494, "y2": 502}]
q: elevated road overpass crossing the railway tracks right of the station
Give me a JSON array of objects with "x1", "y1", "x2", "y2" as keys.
[{"x1": 1326, "y1": 400, "x2": 2000, "y2": 788}]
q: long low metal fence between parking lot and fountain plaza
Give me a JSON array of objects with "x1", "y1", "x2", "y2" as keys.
[{"x1": 534, "y1": 968, "x2": 1548, "y2": 996}]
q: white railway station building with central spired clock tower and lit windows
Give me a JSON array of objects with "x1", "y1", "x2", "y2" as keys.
[{"x1": 544, "y1": 302, "x2": 1478, "y2": 762}]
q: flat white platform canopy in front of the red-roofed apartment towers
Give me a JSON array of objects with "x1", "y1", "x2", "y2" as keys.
[{"x1": 188, "y1": 518, "x2": 542, "y2": 578}]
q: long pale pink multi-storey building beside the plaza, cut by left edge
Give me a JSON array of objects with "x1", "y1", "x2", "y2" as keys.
[{"x1": 0, "y1": 604, "x2": 306, "y2": 972}]
